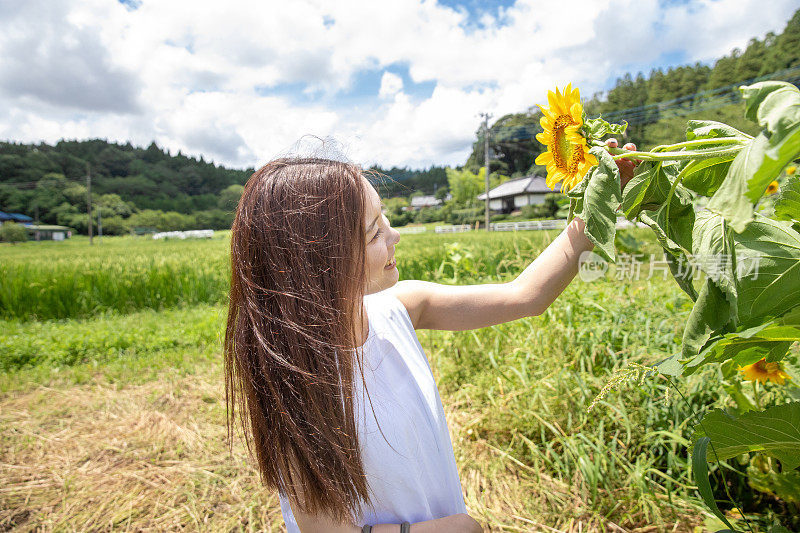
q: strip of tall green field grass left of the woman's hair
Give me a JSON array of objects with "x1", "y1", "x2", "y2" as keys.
[{"x1": 0, "y1": 238, "x2": 230, "y2": 320}]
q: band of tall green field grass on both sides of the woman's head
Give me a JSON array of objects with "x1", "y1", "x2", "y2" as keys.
[{"x1": 0, "y1": 225, "x2": 656, "y2": 320}]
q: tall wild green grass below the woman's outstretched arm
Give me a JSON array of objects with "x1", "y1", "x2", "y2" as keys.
[{"x1": 421, "y1": 280, "x2": 721, "y2": 528}]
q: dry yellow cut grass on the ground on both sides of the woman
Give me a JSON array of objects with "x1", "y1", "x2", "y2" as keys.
[{"x1": 0, "y1": 366, "x2": 688, "y2": 533}]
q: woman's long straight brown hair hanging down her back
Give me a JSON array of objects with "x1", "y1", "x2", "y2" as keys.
[{"x1": 224, "y1": 158, "x2": 369, "y2": 522}]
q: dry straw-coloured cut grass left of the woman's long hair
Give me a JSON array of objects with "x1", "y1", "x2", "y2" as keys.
[{"x1": 0, "y1": 368, "x2": 283, "y2": 531}]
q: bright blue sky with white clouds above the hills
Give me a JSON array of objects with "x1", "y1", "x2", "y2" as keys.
[{"x1": 0, "y1": 0, "x2": 798, "y2": 168}]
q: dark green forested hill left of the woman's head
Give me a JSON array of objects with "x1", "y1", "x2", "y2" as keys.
[{"x1": 0, "y1": 139, "x2": 253, "y2": 233}]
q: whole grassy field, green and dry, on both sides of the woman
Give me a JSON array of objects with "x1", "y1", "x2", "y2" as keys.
[{"x1": 0, "y1": 229, "x2": 722, "y2": 531}]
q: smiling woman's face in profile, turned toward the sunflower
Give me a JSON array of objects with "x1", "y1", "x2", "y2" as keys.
[{"x1": 361, "y1": 177, "x2": 400, "y2": 294}]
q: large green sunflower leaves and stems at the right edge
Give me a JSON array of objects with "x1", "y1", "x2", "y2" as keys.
[{"x1": 552, "y1": 82, "x2": 800, "y2": 529}]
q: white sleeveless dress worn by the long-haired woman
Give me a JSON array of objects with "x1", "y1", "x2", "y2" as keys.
[{"x1": 279, "y1": 291, "x2": 467, "y2": 533}]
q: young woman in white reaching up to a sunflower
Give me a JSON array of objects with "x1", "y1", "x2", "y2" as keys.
[{"x1": 224, "y1": 143, "x2": 632, "y2": 533}]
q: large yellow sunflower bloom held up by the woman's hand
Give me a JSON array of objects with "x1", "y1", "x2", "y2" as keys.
[{"x1": 536, "y1": 84, "x2": 597, "y2": 193}]
